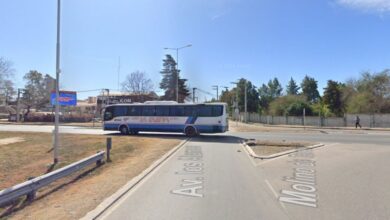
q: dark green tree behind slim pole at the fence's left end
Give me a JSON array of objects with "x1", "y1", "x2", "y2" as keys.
[{"x1": 235, "y1": 78, "x2": 260, "y2": 112}]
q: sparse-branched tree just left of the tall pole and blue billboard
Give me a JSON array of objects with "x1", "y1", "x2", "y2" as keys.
[{"x1": 22, "y1": 70, "x2": 55, "y2": 115}]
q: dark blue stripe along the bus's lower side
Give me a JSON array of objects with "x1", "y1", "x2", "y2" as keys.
[{"x1": 104, "y1": 123, "x2": 226, "y2": 133}]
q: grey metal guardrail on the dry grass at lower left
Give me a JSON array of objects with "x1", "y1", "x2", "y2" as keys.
[{"x1": 0, "y1": 151, "x2": 105, "y2": 206}]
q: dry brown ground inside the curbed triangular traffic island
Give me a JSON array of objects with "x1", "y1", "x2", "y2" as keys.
[{"x1": 250, "y1": 141, "x2": 314, "y2": 156}]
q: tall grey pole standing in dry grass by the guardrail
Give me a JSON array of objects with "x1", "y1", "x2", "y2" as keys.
[{"x1": 53, "y1": 0, "x2": 61, "y2": 164}]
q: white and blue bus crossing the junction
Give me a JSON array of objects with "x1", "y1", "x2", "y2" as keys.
[{"x1": 103, "y1": 101, "x2": 229, "y2": 136}]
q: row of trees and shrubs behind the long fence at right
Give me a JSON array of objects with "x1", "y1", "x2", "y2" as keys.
[{"x1": 221, "y1": 69, "x2": 390, "y2": 117}]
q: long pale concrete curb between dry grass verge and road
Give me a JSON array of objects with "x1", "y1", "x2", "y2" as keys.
[{"x1": 80, "y1": 138, "x2": 191, "y2": 220}]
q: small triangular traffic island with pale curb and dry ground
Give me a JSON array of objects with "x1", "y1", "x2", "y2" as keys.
[{"x1": 243, "y1": 139, "x2": 324, "y2": 159}]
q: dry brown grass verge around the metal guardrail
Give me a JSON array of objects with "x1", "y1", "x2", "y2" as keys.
[{"x1": 0, "y1": 132, "x2": 184, "y2": 219}]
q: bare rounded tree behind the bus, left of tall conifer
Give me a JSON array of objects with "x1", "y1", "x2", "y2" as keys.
[{"x1": 122, "y1": 71, "x2": 153, "y2": 94}]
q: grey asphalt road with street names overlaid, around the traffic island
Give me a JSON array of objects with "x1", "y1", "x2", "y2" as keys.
[{"x1": 0, "y1": 126, "x2": 390, "y2": 220}]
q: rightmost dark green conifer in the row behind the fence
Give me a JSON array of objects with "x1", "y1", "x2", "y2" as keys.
[{"x1": 323, "y1": 80, "x2": 344, "y2": 116}]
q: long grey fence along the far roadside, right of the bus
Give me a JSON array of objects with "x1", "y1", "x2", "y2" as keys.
[{"x1": 233, "y1": 113, "x2": 390, "y2": 128}]
